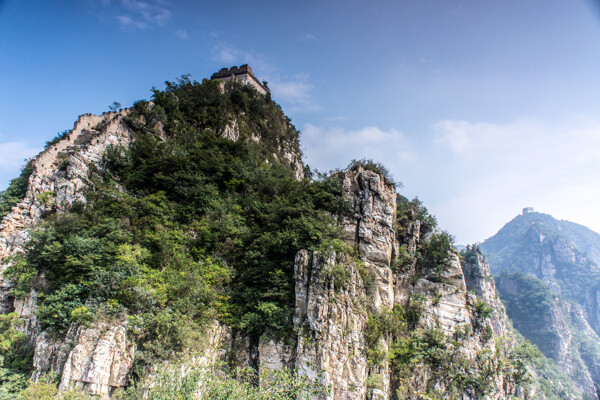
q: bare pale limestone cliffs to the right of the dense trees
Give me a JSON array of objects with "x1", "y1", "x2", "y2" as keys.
[{"x1": 205, "y1": 168, "x2": 518, "y2": 400}]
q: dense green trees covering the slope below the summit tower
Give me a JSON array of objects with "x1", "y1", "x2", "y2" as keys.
[{"x1": 8, "y1": 77, "x2": 347, "y2": 378}]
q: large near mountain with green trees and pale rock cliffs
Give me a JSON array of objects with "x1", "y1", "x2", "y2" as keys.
[{"x1": 0, "y1": 74, "x2": 535, "y2": 400}]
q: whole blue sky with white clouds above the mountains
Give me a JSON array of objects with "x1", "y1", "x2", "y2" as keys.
[{"x1": 0, "y1": 0, "x2": 600, "y2": 243}]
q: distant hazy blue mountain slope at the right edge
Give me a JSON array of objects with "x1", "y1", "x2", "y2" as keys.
[{"x1": 481, "y1": 213, "x2": 600, "y2": 398}]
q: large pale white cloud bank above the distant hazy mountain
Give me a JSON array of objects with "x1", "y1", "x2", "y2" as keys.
[{"x1": 301, "y1": 118, "x2": 600, "y2": 244}]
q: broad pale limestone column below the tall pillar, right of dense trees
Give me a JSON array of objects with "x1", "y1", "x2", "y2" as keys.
[{"x1": 294, "y1": 251, "x2": 367, "y2": 400}]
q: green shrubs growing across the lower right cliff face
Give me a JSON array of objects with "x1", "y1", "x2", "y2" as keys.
[{"x1": 365, "y1": 301, "x2": 527, "y2": 399}]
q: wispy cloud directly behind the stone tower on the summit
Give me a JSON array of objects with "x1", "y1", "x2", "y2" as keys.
[{"x1": 213, "y1": 44, "x2": 320, "y2": 112}]
